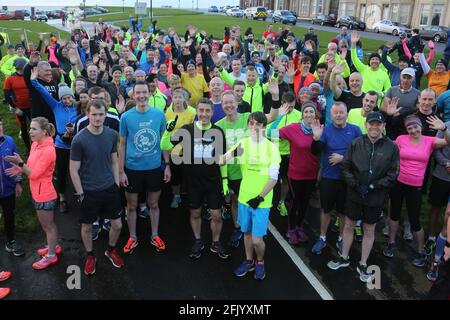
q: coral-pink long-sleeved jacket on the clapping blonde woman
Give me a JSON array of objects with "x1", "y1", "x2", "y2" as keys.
[{"x1": 27, "y1": 137, "x2": 57, "y2": 202}]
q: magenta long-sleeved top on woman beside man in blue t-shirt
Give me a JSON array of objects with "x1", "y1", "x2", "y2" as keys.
[{"x1": 279, "y1": 123, "x2": 319, "y2": 180}]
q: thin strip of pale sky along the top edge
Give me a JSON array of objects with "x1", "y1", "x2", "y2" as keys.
[{"x1": 7, "y1": 0, "x2": 239, "y2": 9}]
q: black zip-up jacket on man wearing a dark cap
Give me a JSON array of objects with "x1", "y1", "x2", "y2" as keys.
[{"x1": 340, "y1": 135, "x2": 400, "y2": 207}]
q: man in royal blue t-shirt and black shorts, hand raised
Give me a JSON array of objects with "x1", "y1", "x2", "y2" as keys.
[{"x1": 311, "y1": 101, "x2": 362, "y2": 254}]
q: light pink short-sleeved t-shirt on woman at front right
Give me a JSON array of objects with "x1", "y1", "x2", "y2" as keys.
[{"x1": 395, "y1": 135, "x2": 436, "y2": 187}]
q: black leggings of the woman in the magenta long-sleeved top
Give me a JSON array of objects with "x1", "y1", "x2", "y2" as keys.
[{"x1": 286, "y1": 178, "x2": 317, "y2": 230}]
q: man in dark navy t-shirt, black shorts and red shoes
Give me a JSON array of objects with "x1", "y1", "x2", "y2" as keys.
[{"x1": 70, "y1": 99, "x2": 124, "y2": 276}]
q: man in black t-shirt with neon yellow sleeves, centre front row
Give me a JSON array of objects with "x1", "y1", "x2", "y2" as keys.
[{"x1": 161, "y1": 99, "x2": 230, "y2": 259}]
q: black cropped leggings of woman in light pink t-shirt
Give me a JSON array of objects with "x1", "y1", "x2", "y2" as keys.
[{"x1": 389, "y1": 181, "x2": 422, "y2": 232}]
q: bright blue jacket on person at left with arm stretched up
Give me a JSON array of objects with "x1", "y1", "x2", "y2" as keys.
[{"x1": 31, "y1": 80, "x2": 77, "y2": 149}]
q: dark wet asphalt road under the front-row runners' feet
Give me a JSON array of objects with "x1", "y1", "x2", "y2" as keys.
[{"x1": 0, "y1": 180, "x2": 431, "y2": 300}]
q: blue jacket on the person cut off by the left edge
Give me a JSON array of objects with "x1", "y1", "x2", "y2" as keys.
[{"x1": 0, "y1": 134, "x2": 22, "y2": 198}]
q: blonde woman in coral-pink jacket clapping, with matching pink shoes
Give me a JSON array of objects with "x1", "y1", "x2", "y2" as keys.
[{"x1": 4, "y1": 117, "x2": 61, "y2": 270}]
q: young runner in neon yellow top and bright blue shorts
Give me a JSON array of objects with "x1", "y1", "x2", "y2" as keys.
[{"x1": 221, "y1": 112, "x2": 281, "y2": 280}]
